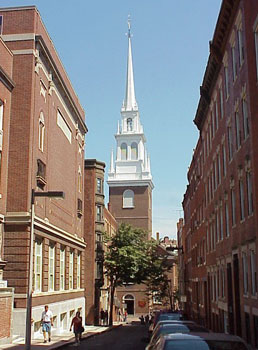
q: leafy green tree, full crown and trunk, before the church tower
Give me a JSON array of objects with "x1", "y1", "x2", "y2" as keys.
[{"x1": 104, "y1": 223, "x2": 174, "y2": 325}]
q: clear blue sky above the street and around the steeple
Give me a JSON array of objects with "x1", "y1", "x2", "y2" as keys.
[{"x1": 0, "y1": 0, "x2": 221, "y2": 237}]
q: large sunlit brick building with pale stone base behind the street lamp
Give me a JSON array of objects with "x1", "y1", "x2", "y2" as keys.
[{"x1": 0, "y1": 6, "x2": 87, "y2": 337}]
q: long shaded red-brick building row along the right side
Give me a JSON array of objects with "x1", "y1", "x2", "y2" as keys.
[{"x1": 183, "y1": 0, "x2": 258, "y2": 347}]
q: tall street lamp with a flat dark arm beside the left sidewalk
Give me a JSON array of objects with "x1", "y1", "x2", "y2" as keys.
[{"x1": 25, "y1": 189, "x2": 65, "y2": 350}]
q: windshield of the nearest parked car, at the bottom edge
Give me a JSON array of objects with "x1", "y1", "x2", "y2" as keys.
[{"x1": 164, "y1": 339, "x2": 247, "y2": 350}]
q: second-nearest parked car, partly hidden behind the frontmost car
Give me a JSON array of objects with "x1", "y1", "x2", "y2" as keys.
[{"x1": 145, "y1": 321, "x2": 209, "y2": 350}]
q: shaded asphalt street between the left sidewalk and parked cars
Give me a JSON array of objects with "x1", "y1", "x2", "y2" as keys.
[{"x1": 59, "y1": 322, "x2": 147, "y2": 350}]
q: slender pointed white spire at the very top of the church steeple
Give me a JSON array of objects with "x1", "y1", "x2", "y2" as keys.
[{"x1": 123, "y1": 16, "x2": 138, "y2": 111}]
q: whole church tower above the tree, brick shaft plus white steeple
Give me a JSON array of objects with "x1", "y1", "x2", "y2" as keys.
[{"x1": 108, "y1": 21, "x2": 154, "y2": 237}]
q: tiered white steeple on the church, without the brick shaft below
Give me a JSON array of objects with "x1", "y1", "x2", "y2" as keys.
[{"x1": 108, "y1": 18, "x2": 153, "y2": 188}]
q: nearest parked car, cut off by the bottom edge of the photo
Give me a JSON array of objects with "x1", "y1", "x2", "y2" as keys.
[{"x1": 152, "y1": 333, "x2": 248, "y2": 350}]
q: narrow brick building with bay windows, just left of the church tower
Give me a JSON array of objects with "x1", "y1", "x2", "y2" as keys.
[{"x1": 84, "y1": 159, "x2": 105, "y2": 325}]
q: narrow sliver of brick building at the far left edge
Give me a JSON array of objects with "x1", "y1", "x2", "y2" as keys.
[{"x1": 0, "y1": 32, "x2": 15, "y2": 344}]
